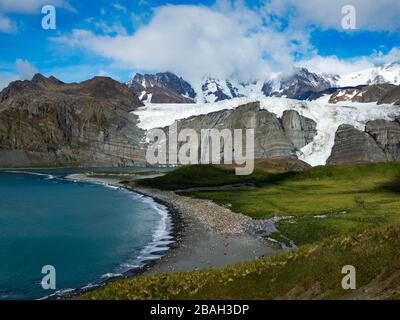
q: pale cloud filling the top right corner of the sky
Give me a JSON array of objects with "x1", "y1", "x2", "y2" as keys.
[{"x1": 263, "y1": 0, "x2": 400, "y2": 31}]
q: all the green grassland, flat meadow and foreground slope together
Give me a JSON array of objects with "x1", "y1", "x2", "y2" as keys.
[{"x1": 86, "y1": 163, "x2": 400, "y2": 299}]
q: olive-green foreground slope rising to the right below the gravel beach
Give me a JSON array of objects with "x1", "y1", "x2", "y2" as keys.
[{"x1": 83, "y1": 226, "x2": 400, "y2": 300}]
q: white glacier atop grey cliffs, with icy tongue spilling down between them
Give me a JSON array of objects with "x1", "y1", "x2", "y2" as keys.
[{"x1": 133, "y1": 95, "x2": 400, "y2": 166}]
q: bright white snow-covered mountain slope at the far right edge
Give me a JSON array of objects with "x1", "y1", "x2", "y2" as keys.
[{"x1": 338, "y1": 62, "x2": 400, "y2": 87}]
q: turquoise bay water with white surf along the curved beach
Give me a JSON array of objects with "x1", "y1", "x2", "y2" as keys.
[{"x1": 0, "y1": 171, "x2": 171, "y2": 299}]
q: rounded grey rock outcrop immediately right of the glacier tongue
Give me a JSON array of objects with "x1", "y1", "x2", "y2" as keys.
[{"x1": 327, "y1": 125, "x2": 387, "y2": 164}]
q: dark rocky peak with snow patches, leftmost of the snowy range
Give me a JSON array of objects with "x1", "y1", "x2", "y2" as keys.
[{"x1": 127, "y1": 72, "x2": 196, "y2": 103}]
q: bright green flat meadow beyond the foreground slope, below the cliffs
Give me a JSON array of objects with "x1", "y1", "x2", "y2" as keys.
[{"x1": 139, "y1": 163, "x2": 400, "y2": 245}]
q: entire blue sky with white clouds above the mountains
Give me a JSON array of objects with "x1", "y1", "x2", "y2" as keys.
[{"x1": 0, "y1": 0, "x2": 400, "y2": 87}]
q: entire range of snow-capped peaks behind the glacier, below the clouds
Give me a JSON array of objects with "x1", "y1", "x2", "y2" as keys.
[{"x1": 127, "y1": 62, "x2": 400, "y2": 103}]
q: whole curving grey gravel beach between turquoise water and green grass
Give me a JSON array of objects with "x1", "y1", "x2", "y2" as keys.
[{"x1": 61, "y1": 174, "x2": 280, "y2": 299}]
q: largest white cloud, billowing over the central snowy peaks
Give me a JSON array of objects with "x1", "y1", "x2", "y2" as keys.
[{"x1": 54, "y1": 2, "x2": 308, "y2": 82}]
